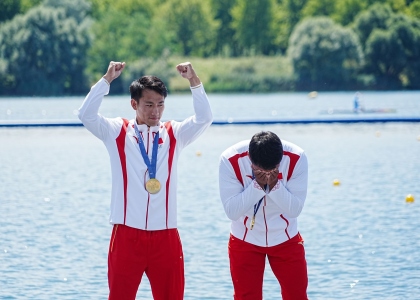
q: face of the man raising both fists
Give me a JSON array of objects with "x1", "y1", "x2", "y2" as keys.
[{"x1": 131, "y1": 89, "x2": 165, "y2": 126}]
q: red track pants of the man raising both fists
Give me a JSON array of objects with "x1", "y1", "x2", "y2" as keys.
[{"x1": 108, "y1": 224, "x2": 185, "y2": 300}]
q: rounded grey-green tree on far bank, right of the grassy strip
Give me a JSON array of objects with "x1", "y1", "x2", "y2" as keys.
[{"x1": 288, "y1": 17, "x2": 363, "y2": 90}]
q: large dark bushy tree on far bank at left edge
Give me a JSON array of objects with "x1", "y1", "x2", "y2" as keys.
[{"x1": 0, "y1": 2, "x2": 90, "y2": 95}]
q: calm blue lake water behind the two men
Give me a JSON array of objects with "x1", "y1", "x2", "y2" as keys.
[{"x1": 0, "y1": 92, "x2": 420, "y2": 300}]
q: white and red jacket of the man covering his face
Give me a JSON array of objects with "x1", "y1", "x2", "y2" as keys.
[{"x1": 219, "y1": 140, "x2": 308, "y2": 247}]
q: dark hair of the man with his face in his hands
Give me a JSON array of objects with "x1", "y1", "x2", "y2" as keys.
[{"x1": 248, "y1": 131, "x2": 283, "y2": 170}]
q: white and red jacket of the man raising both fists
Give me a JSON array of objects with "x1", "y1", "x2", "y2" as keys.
[{"x1": 79, "y1": 79, "x2": 213, "y2": 230}]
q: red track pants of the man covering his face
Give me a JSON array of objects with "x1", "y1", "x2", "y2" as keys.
[{"x1": 229, "y1": 233, "x2": 308, "y2": 300}]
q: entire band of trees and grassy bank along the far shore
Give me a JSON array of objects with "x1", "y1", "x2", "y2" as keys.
[{"x1": 0, "y1": 0, "x2": 420, "y2": 96}]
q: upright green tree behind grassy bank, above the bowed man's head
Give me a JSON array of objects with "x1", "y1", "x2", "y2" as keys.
[{"x1": 232, "y1": 0, "x2": 277, "y2": 55}]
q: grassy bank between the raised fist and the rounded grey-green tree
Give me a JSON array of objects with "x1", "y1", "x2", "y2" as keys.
[{"x1": 169, "y1": 56, "x2": 293, "y2": 93}]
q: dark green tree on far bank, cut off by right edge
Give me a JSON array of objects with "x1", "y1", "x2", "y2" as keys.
[{"x1": 354, "y1": 4, "x2": 420, "y2": 89}]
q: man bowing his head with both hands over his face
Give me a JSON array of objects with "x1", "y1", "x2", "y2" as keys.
[{"x1": 219, "y1": 131, "x2": 308, "y2": 300}]
